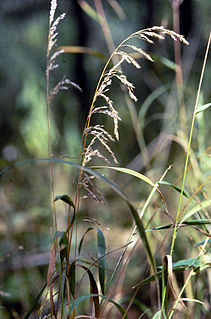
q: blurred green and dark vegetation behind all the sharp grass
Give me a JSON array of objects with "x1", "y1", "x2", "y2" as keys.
[{"x1": 0, "y1": 0, "x2": 211, "y2": 319}]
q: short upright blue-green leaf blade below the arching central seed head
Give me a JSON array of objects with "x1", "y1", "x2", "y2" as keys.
[{"x1": 97, "y1": 229, "x2": 106, "y2": 295}]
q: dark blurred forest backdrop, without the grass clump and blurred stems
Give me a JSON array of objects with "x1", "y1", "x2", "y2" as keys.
[{"x1": 0, "y1": 0, "x2": 211, "y2": 319}]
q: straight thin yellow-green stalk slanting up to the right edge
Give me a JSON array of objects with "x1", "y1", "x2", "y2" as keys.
[{"x1": 170, "y1": 32, "x2": 211, "y2": 256}]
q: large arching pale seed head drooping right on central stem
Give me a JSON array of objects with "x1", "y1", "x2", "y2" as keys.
[{"x1": 82, "y1": 26, "x2": 188, "y2": 169}]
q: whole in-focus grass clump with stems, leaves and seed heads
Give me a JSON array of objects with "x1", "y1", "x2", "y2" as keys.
[{"x1": 1, "y1": 0, "x2": 211, "y2": 319}]
